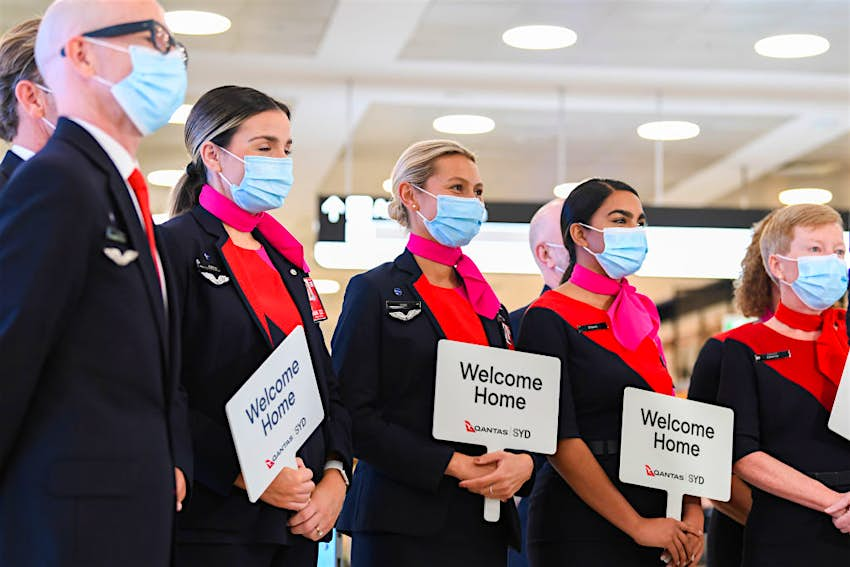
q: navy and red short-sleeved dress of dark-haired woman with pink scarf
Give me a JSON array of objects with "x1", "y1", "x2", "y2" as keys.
[{"x1": 518, "y1": 291, "x2": 673, "y2": 567}]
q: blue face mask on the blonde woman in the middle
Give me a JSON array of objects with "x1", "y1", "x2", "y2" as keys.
[{"x1": 411, "y1": 183, "x2": 487, "y2": 248}]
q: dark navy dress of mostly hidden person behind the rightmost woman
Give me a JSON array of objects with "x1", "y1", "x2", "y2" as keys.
[{"x1": 688, "y1": 332, "x2": 744, "y2": 567}]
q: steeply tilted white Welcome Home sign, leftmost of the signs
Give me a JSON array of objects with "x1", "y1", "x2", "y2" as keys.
[{"x1": 224, "y1": 325, "x2": 325, "y2": 502}]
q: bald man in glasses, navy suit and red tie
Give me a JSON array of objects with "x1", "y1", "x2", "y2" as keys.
[{"x1": 0, "y1": 0, "x2": 191, "y2": 567}]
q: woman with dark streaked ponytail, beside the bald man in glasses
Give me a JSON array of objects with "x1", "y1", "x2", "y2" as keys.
[{"x1": 159, "y1": 86, "x2": 351, "y2": 567}]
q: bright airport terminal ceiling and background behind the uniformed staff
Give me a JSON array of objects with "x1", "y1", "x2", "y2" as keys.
[{"x1": 0, "y1": 0, "x2": 850, "y2": 564}]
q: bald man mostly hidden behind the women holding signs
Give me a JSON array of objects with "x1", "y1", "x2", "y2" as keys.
[{"x1": 508, "y1": 199, "x2": 570, "y2": 567}]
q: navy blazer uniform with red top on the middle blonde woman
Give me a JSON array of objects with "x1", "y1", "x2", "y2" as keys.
[{"x1": 333, "y1": 251, "x2": 530, "y2": 567}]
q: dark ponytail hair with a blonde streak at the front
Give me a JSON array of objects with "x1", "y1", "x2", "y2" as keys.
[{"x1": 169, "y1": 85, "x2": 292, "y2": 217}]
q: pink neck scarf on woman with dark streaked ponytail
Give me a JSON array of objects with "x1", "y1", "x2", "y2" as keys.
[{"x1": 198, "y1": 185, "x2": 310, "y2": 273}]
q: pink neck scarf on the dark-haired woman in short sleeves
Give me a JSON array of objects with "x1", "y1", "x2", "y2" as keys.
[{"x1": 570, "y1": 264, "x2": 664, "y2": 358}]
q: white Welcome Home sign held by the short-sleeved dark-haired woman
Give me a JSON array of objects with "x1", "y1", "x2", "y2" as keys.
[{"x1": 620, "y1": 388, "x2": 734, "y2": 520}]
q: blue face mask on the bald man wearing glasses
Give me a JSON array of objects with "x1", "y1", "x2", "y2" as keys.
[{"x1": 86, "y1": 37, "x2": 188, "y2": 136}]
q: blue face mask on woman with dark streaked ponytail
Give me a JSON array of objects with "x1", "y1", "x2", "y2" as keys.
[{"x1": 219, "y1": 148, "x2": 293, "y2": 214}]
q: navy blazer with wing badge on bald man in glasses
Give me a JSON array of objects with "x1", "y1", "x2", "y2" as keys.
[{"x1": 0, "y1": 119, "x2": 192, "y2": 567}]
